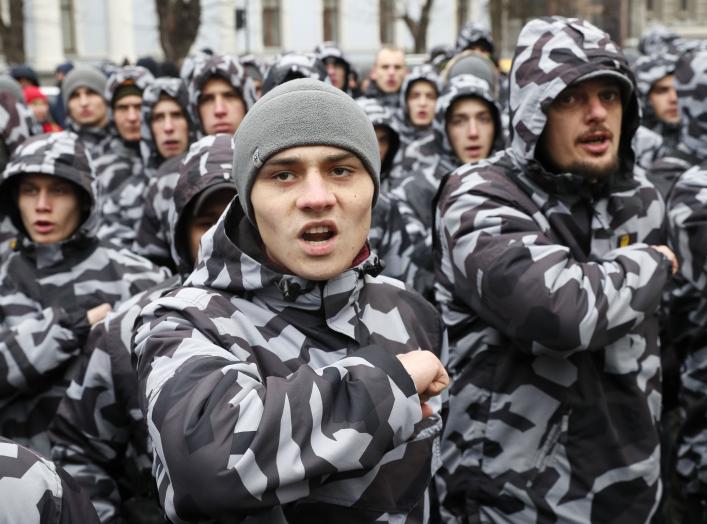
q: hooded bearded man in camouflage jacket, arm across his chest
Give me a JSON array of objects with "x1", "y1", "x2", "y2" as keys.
[{"x1": 433, "y1": 17, "x2": 677, "y2": 523}]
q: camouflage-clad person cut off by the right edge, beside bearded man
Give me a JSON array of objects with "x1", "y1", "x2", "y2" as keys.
[{"x1": 664, "y1": 51, "x2": 707, "y2": 523}]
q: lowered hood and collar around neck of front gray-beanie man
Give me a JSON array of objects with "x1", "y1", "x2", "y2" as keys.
[{"x1": 185, "y1": 194, "x2": 382, "y2": 309}]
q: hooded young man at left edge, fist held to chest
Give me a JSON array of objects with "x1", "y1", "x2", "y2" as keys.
[{"x1": 0, "y1": 131, "x2": 169, "y2": 455}]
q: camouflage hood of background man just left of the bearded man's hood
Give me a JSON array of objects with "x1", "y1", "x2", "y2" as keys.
[{"x1": 433, "y1": 75, "x2": 503, "y2": 162}]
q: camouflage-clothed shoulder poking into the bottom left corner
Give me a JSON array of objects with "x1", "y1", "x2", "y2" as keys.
[{"x1": 0, "y1": 437, "x2": 98, "y2": 524}]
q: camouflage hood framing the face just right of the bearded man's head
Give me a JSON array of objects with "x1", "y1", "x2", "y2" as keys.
[{"x1": 633, "y1": 53, "x2": 681, "y2": 148}]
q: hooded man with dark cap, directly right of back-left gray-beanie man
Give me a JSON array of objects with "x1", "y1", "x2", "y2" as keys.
[{"x1": 94, "y1": 66, "x2": 155, "y2": 248}]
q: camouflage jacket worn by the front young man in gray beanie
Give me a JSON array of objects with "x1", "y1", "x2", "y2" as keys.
[{"x1": 134, "y1": 199, "x2": 445, "y2": 523}]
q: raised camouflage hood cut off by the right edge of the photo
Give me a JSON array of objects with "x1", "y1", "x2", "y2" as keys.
[{"x1": 674, "y1": 51, "x2": 707, "y2": 160}]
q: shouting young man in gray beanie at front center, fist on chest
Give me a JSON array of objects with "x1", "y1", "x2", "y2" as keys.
[{"x1": 134, "y1": 79, "x2": 448, "y2": 523}]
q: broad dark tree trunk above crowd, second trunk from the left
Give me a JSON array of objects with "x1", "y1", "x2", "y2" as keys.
[{"x1": 155, "y1": 0, "x2": 201, "y2": 64}]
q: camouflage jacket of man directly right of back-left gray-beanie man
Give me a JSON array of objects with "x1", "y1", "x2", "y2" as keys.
[{"x1": 95, "y1": 66, "x2": 154, "y2": 248}]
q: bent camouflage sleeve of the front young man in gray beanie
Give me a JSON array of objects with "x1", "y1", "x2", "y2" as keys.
[{"x1": 134, "y1": 288, "x2": 421, "y2": 518}]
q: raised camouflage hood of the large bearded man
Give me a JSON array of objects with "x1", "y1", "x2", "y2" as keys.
[{"x1": 509, "y1": 16, "x2": 640, "y2": 172}]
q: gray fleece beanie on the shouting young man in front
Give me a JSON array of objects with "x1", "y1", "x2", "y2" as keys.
[{"x1": 233, "y1": 78, "x2": 380, "y2": 224}]
